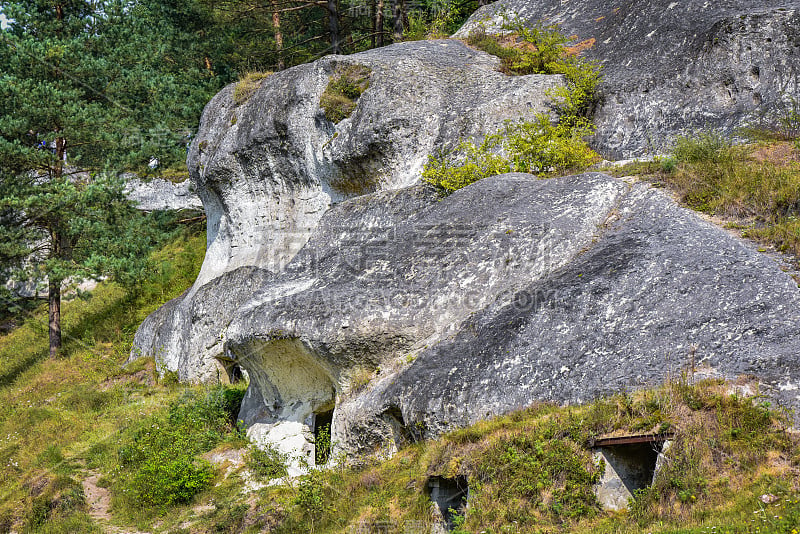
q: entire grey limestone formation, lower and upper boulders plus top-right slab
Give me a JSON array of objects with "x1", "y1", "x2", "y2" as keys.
[{"x1": 134, "y1": 0, "x2": 800, "y2": 461}]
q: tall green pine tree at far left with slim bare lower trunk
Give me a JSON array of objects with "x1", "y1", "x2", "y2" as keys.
[{"x1": 0, "y1": 0, "x2": 219, "y2": 357}]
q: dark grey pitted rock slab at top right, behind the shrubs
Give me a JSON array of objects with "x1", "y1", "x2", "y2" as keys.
[{"x1": 456, "y1": 0, "x2": 800, "y2": 158}]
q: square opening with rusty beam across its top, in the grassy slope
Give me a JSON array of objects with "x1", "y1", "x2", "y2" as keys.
[{"x1": 592, "y1": 434, "x2": 672, "y2": 510}]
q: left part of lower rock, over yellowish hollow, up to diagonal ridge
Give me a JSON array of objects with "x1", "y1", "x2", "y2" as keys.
[{"x1": 226, "y1": 175, "x2": 625, "y2": 460}]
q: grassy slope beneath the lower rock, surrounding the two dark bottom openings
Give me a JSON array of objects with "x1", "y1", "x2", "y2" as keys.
[{"x1": 230, "y1": 381, "x2": 800, "y2": 534}]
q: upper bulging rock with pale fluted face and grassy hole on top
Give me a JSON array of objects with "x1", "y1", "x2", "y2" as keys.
[{"x1": 133, "y1": 40, "x2": 563, "y2": 380}]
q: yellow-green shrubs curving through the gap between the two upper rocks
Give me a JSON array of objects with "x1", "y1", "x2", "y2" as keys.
[{"x1": 432, "y1": 20, "x2": 601, "y2": 195}]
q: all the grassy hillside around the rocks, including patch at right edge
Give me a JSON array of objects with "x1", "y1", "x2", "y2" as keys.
[{"x1": 0, "y1": 137, "x2": 800, "y2": 534}]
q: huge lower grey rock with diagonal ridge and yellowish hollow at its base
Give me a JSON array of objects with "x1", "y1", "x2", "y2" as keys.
[{"x1": 225, "y1": 174, "x2": 800, "y2": 464}]
